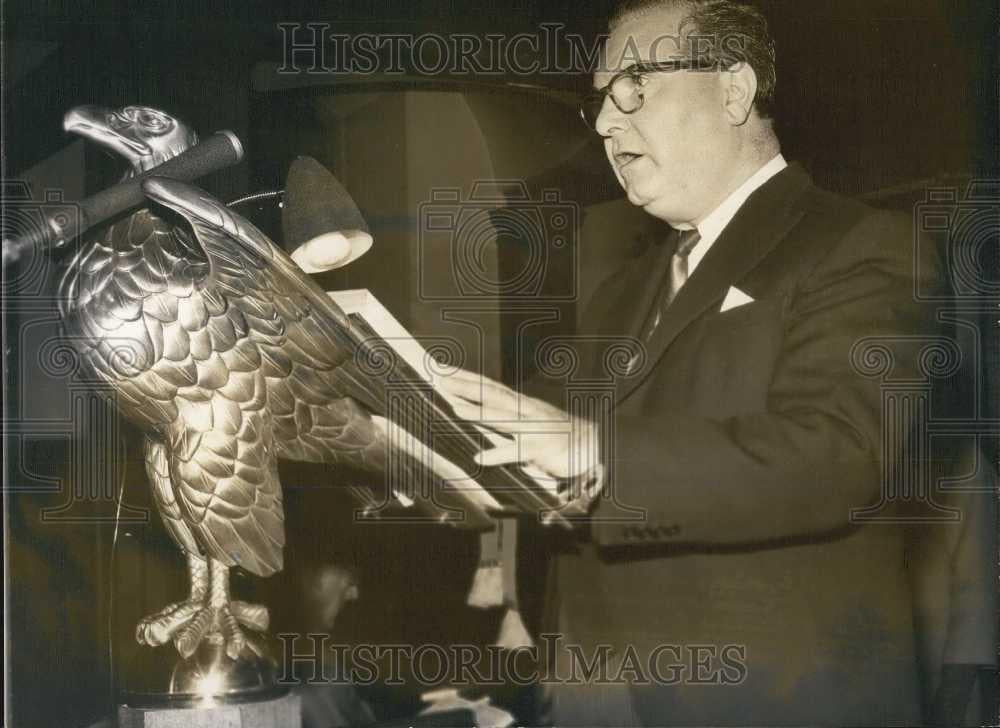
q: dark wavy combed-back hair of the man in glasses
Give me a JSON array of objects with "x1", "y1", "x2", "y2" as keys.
[{"x1": 608, "y1": 0, "x2": 777, "y2": 119}]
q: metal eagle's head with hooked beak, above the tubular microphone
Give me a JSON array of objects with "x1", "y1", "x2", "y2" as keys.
[{"x1": 63, "y1": 105, "x2": 198, "y2": 177}]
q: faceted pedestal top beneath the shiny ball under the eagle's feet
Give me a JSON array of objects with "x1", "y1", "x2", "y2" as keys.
[{"x1": 118, "y1": 694, "x2": 302, "y2": 728}]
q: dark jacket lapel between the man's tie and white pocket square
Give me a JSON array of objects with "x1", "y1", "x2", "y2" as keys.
[{"x1": 616, "y1": 164, "x2": 811, "y2": 402}]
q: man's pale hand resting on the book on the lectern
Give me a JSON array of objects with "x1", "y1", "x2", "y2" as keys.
[{"x1": 438, "y1": 370, "x2": 601, "y2": 480}]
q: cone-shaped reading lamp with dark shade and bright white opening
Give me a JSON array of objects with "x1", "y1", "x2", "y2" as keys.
[{"x1": 281, "y1": 156, "x2": 372, "y2": 273}]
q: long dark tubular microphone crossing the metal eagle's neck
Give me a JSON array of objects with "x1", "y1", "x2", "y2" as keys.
[{"x1": 3, "y1": 130, "x2": 243, "y2": 266}]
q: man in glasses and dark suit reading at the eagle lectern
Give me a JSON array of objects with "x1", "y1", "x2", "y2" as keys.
[{"x1": 445, "y1": 0, "x2": 939, "y2": 726}]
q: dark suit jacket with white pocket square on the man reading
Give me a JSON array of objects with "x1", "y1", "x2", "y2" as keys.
[{"x1": 548, "y1": 165, "x2": 939, "y2": 725}]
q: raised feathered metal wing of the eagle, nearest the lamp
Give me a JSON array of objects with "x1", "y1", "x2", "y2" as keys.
[{"x1": 144, "y1": 178, "x2": 384, "y2": 469}]
